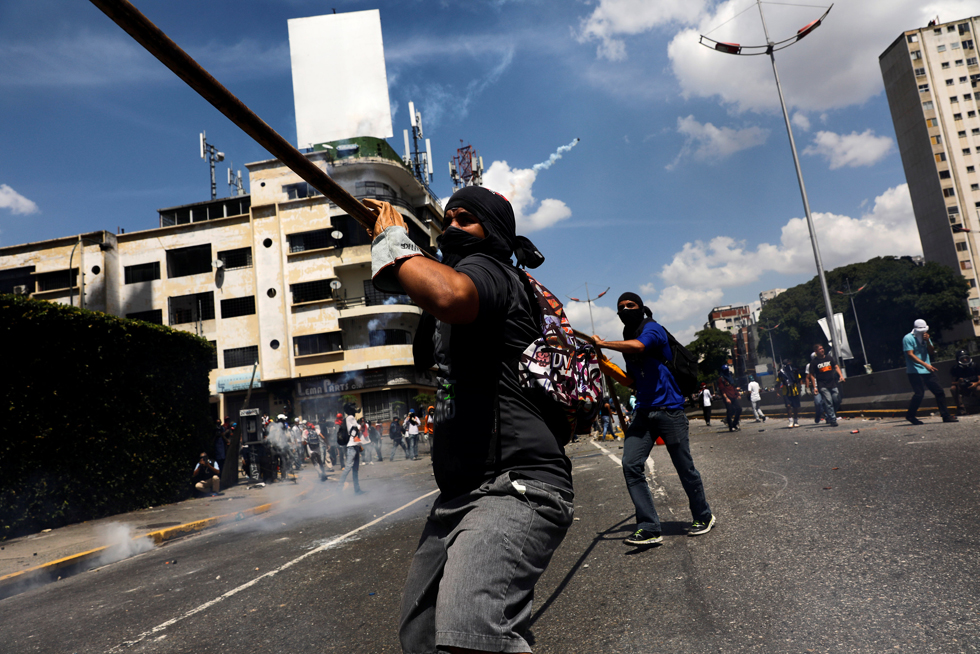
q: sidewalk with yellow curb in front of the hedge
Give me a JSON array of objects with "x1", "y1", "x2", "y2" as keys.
[{"x1": 0, "y1": 465, "x2": 348, "y2": 599}]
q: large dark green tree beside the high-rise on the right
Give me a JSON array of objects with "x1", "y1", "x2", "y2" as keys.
[{"x1": 760, "y1": 257, "x2": 970, "y2": 370}]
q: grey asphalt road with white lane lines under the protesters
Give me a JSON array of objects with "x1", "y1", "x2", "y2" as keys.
[{"x1": 0, "y1": 417, "x2": 980, "y2": 654}]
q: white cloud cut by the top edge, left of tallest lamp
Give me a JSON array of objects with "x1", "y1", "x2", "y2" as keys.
[{"x1": 577, "y1": 0, "x2": 705, "y2": 61}]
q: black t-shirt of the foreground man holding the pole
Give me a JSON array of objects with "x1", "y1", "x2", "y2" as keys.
[{"x1": 424, "y1": 254, "x2": 572, "y2": 497}]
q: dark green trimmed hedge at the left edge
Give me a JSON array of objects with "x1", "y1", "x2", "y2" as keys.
[{"x1": 0, "y1": 294, "x2": 214, "y2": 540}]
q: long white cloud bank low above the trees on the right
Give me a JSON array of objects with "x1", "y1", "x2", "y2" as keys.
[{"x1": 641, "y1": 184, "x2": 922, "y2": 343}]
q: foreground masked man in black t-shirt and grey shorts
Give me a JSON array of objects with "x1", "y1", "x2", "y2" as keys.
[{"x1": 365, "y1": 186, "x2": 573, "y2": 652}]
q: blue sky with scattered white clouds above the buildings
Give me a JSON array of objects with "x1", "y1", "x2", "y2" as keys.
[{"x1": 0, "y1": 0, "x2": 975, "y2": 342}]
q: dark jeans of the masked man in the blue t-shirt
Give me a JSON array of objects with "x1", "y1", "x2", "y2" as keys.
[{"x1": 623, "y1": 408, "x2": 711, "y2": 534}]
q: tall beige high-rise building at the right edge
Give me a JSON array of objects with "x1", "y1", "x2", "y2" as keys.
[{"x1": 878, "y1": 16, "x2": 980, "y2": 338}]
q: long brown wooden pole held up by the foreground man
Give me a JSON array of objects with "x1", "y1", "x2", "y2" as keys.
[{"x1": 91, "y1": 0, "x2": 375, "y2": 229}]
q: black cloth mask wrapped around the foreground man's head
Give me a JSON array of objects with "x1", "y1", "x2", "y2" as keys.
[{"x1": 436, "y1": 186, "x2": 544, "y2": 268}]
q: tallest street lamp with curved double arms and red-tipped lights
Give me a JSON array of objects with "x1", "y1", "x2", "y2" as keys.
[{"x1": 700, "y1": 0, "x2": 841, "y2": 365}]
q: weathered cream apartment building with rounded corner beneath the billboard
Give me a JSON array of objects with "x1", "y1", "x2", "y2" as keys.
[{"x1": 0, "y1": 137, "x2": 443, "y2": 422}]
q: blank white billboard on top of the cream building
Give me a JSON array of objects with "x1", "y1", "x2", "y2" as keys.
[{"x1": 288, "y1": 9, "x2": 392, "y2": 148}]
